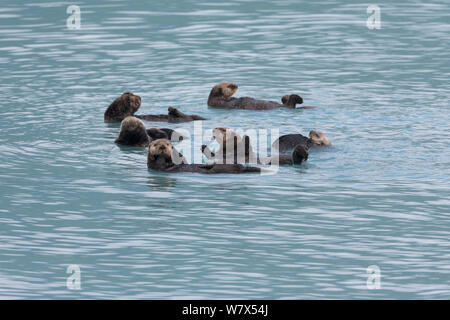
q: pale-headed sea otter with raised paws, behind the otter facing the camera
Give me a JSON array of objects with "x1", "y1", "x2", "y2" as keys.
[{"x1": 202, "y1": 128, "x2": 308, "y2": 165}]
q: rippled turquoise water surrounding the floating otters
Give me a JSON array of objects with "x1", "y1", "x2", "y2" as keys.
[{"x1": 0, "y1": 0, "x2": 450, "y2": 299}]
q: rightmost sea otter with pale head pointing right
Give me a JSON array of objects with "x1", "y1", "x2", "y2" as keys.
[{"x1": 272, "y1": 130, "x2": 331, "y2": 152}]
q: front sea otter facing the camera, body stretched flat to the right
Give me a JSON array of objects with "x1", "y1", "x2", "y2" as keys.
[{"x1": 147, "y1": 139, "x2": 261, "y2": 174}]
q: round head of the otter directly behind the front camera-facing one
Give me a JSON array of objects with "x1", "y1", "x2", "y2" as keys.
[{"x1": 115, "y1": 116, "x2": 150, "y2": 147}]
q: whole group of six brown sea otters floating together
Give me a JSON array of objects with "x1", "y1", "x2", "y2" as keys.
[{"x1": 105, "y1": 81, "x2": 331, "y2": 173}]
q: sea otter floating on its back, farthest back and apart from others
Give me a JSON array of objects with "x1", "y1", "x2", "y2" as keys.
[{"x1": 208, "y1": 81, "x2": 314, "y2": 110}]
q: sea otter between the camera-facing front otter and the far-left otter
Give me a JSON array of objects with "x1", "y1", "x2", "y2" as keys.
[{"x1": 115, "y1": 116, "x2": 183, "y2": 147}]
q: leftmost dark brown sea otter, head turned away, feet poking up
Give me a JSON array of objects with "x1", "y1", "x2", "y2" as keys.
[{"x1": 104, "y1": 92, "x2": 205, "y2": 122}]
